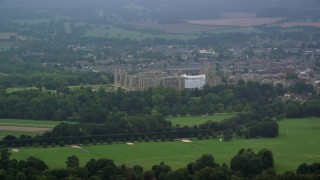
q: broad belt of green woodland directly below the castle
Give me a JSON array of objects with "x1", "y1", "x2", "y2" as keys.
[{"x1": 0, "y1": 81, "x2": 320, "y2": 123}]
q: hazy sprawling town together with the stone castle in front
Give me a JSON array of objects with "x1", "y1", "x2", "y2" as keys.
[{"x1": 57, "y1": 44, "x2": 320, "y2": 91}]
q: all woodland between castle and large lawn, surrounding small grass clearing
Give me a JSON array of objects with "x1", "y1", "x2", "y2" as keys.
[{"x1": 0, "y1": 82, "x2": 320, "y2": 147}]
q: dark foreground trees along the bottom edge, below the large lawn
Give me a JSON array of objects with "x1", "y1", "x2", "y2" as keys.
[{"x1": 0, "y1": 149, "x2": 320, "y2": 180}]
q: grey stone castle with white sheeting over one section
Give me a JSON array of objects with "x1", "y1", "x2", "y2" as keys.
[{"x1": 114, "y1": 63, "x2": 221, "y2": 91}]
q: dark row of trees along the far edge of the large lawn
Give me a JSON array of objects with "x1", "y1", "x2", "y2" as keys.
[{"x1": 0, "y1": 114, "x2": 279, "y2": 147}]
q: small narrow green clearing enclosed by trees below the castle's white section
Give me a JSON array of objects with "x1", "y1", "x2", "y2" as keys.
[{"x1": 166, "y1": 113, "x2": 235, "y2": 127}]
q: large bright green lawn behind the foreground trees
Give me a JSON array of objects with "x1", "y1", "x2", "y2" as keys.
[{"x1": 11, "y1": 118, "x2": 320, "y2": 172}]
